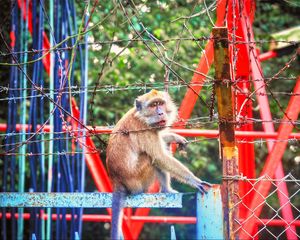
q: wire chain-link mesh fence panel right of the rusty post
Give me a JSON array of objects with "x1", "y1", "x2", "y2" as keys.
[{"x1": 232, "y1": 174, "x2": 300, "y2": 239}]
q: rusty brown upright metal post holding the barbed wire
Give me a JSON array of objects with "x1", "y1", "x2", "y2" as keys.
[{"x1": 212, "y1": 27, "x2": 239, "y2": 239}]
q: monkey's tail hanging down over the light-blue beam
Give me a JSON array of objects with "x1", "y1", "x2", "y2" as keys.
[{"x1": 110, "y1": 192, "x2": 126, "y2": 240}]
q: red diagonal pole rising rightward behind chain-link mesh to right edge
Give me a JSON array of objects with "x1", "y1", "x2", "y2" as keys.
[{"x1": 240, "y1": 78, "x2": 300, "y2": 239}]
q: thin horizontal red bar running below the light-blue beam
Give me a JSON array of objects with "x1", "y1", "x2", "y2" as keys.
[{"x1": 0, "y1": 213, "x2": 300, "y2": 227}]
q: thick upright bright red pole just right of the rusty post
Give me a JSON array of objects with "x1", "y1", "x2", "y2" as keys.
[{"x1": 227, "y1": 0, "x2": 255, "y2": 221}]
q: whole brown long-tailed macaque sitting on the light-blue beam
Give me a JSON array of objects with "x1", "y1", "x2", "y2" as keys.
[{"x1": 106, "y1": 90, "x2": 211, "y2": 239}]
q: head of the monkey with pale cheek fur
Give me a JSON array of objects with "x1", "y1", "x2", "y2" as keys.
[{"x1": 135, "y1": 92, "x2": 177, "y2": 128}]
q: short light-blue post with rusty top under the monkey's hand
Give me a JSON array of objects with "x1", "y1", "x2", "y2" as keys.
[{"x1": 196, "y1": 185, "x2": 224, "y2": 239}]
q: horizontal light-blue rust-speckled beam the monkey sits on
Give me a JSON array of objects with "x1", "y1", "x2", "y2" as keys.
[{"x1": 0, "y1": 192, "x2": 182, "y2": 208}]
